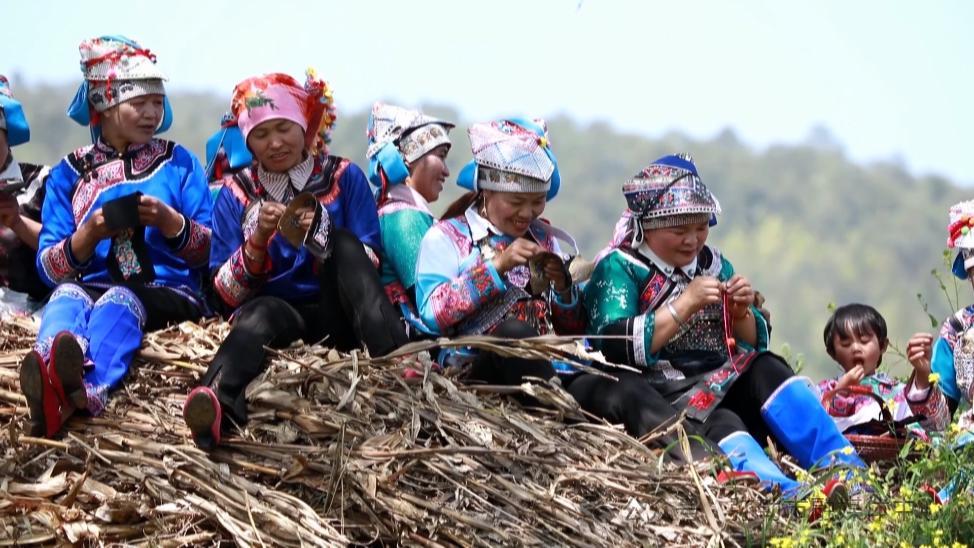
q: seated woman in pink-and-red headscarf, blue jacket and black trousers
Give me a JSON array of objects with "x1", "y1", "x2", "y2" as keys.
[{"x1": 183, "y1": 71, "x2": 408, "y2": 448}]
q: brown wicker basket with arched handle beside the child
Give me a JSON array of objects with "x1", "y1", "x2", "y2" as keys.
[{"x1": 822, "y1": 385, "x2": 920, "y2": 463}]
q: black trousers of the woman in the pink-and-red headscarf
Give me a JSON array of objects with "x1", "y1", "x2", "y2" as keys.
[{"x1": 201, "y1": 230, "x2": 408, "y2": 424}]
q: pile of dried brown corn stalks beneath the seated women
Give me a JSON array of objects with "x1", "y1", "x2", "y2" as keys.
[{"x1": 0, "y1": 318, "x2": 768, "y2": 546}]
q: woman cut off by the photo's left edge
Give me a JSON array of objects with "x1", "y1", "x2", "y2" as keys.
[{"x1": 0, "y1": 75, "x2": 51, "y2": 301}]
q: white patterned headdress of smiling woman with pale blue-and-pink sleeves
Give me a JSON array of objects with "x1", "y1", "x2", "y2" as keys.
[{"x1": 457, "y1": 118, "x2": 561, "y2": 200}]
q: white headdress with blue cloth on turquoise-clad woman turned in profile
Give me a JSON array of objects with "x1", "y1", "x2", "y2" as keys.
[{"x1": 366, "y1": 103, "x2": 454, "y2": 189}]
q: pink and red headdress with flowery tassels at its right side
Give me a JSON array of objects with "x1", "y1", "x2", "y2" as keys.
[{"x1": 230, "y1": 68, "x2": 335, "y2": 153}]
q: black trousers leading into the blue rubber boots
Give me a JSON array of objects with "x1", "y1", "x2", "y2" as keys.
[{"x1": 568, "y1": 353, "x2": 794, "y2": 461}]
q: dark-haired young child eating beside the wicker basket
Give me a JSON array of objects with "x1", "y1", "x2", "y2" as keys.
[{"x1": 818, "y1": 303, "x2": 947, "y2": 439}]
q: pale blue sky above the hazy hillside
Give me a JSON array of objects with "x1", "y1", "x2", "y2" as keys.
[{"x1": 0, "y1": 0, "x2": 974, "y2": 183}]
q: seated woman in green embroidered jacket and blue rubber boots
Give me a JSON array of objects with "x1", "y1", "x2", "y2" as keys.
[{"x1": 585, "y1": 155, "x2": 863, "y2": 493}]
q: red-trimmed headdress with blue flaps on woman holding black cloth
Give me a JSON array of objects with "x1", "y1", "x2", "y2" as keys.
[{"x1": 68, "y1": 36, "x2": 172, "y2": 140}]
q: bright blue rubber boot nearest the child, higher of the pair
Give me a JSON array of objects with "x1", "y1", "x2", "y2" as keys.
[{"x1": 761, "y1": 377, "x2": 866, "y2": 470}]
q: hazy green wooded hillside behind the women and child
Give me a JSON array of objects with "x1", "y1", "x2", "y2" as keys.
[{"x1": 7, "y1": 82, "x2": 971, "y2": 378}]
